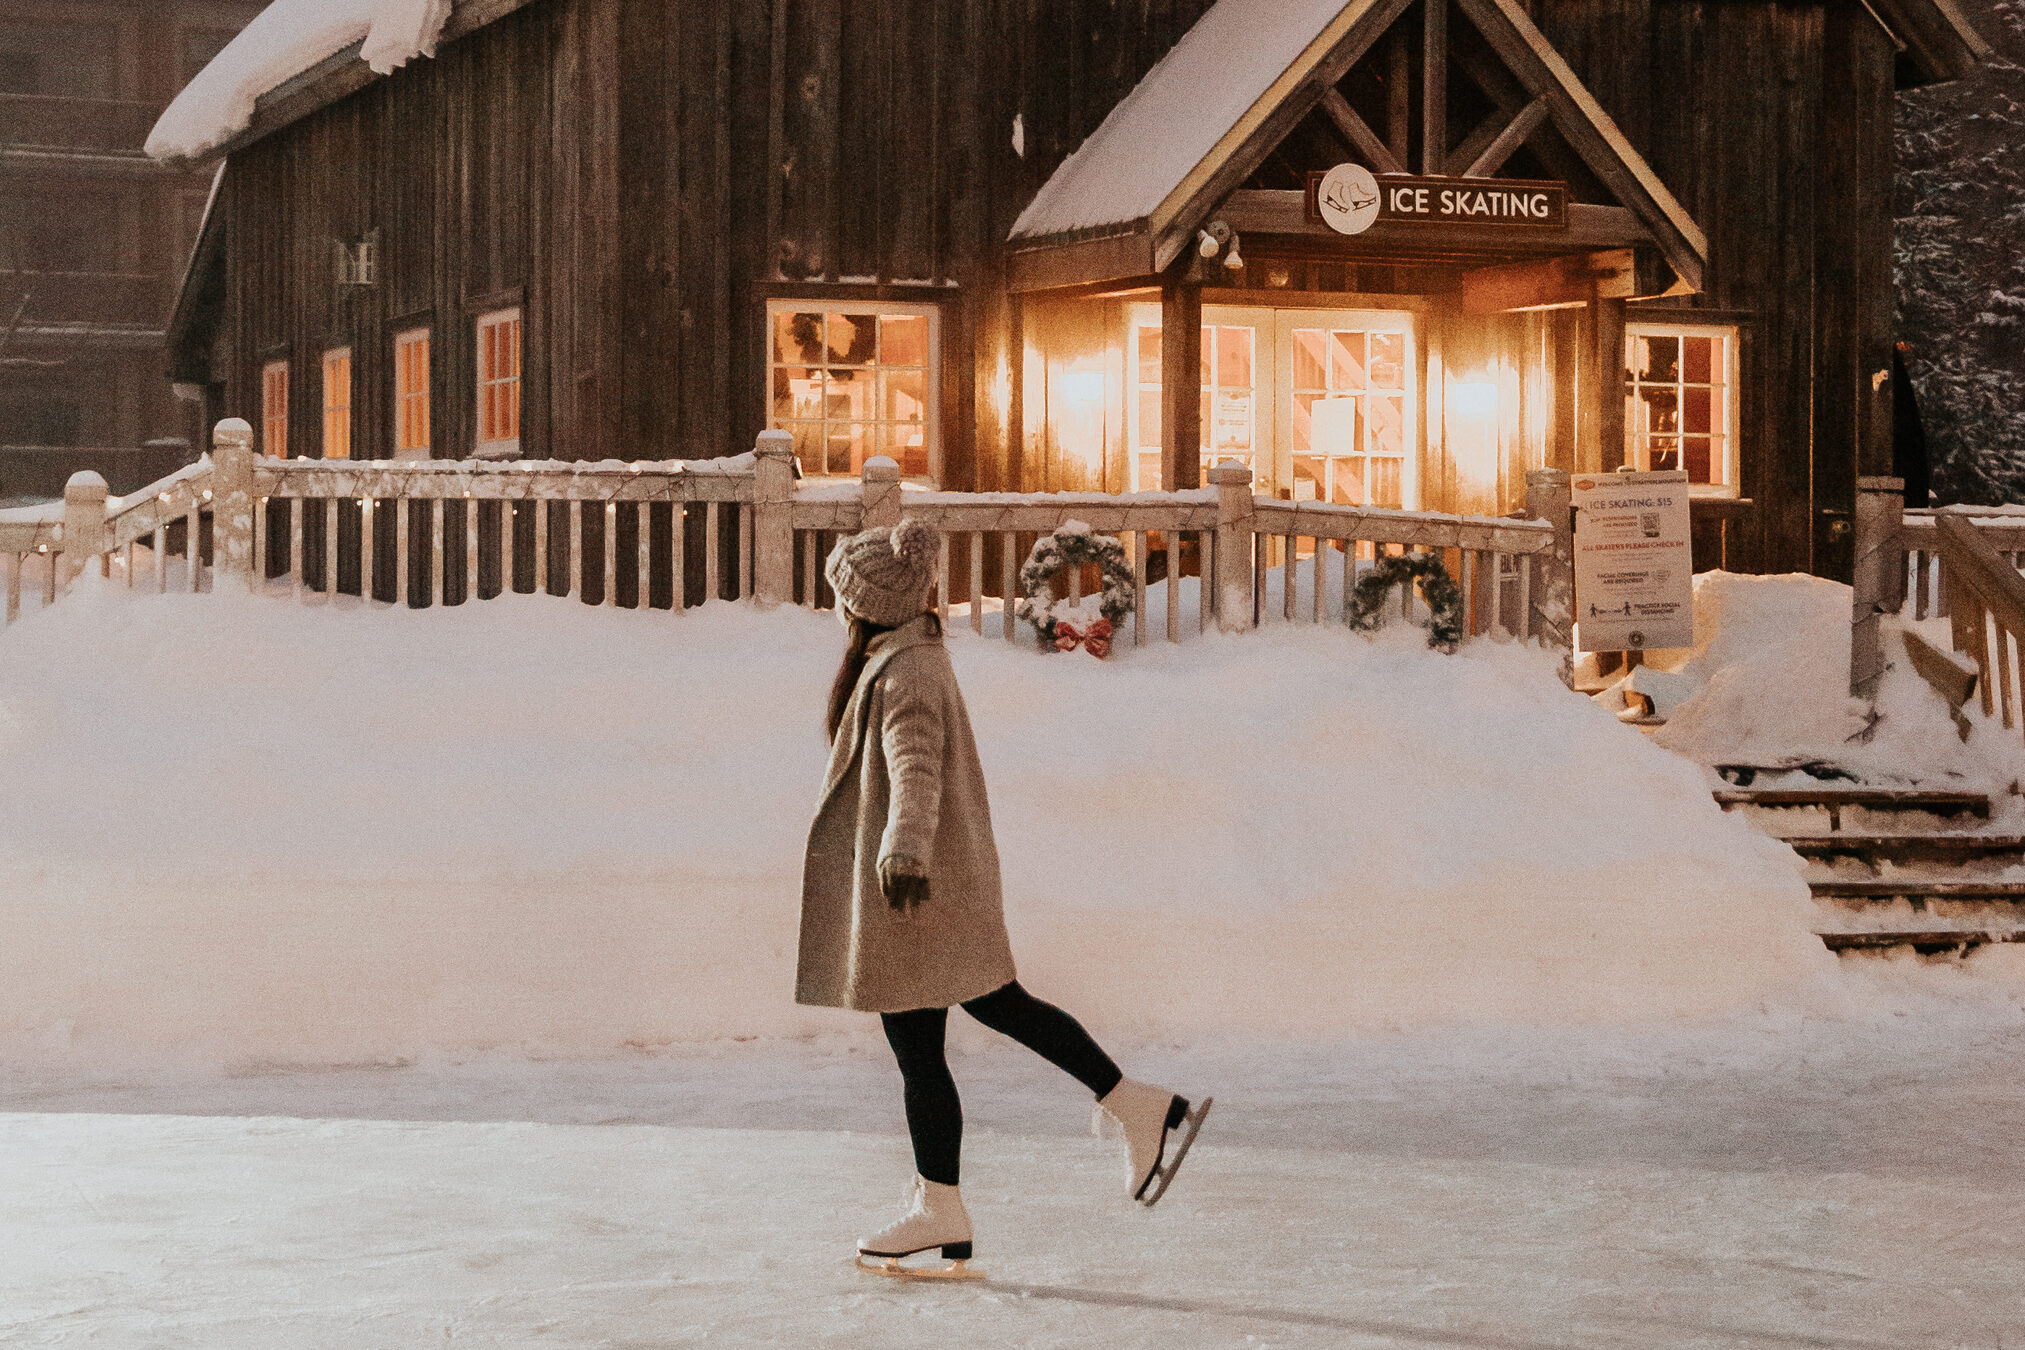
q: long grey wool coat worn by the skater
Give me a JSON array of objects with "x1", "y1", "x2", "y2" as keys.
[{"x1": 794, "y1": 615, "x2": 1015, "y2": 1012}]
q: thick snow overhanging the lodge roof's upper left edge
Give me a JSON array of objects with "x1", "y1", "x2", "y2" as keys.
[{"x1": 148, "y1": 0, "x2": 452, "y2": 160}]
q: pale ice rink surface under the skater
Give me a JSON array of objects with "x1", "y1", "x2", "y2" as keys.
[{"x1": 0, "y1": 1000, "x2": 2025, "y2": 1350}]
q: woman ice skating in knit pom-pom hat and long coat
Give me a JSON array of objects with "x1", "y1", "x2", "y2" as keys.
[{"x1": 796, "y1": 520, "x2": 1211, "y2": 1277}]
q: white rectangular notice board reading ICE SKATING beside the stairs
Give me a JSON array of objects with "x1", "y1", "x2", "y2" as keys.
[{"x1": 1571, "y1": 470, "x2": 1695, "y2": 652}]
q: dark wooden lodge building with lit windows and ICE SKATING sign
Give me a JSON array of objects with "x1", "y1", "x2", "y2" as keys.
[{"x1": 153, "y1": 0, "x2": 1982, "y2": 579}]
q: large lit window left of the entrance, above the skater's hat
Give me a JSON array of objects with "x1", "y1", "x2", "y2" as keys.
[{"x1": 767, "y1": 300, "x2": 942, "y2": 480}]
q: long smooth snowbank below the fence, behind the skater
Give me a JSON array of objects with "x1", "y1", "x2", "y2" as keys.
[{"x1": 0, "y1": 581, "x2": 1833, "y2": 1063}]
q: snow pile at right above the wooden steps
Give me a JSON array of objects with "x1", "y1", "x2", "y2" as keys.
[{"x1": 1632, "y1": 573, "x2": 2025, "y2": 793}]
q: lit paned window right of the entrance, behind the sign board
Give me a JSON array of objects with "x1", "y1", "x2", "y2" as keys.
[{"x1": 1624, "y1": 324, "x2": 1737, "y2": 494}]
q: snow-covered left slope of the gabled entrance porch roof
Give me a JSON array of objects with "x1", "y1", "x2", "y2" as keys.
[{"x1": 1013, "y1": 0, "x2": 1373, "y2": 239}]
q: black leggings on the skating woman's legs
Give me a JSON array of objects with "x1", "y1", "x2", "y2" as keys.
[{"x1": 879, "y1": 980, "x2": 1124, "y2": 1186}]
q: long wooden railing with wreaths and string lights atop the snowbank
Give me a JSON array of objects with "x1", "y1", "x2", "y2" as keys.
[{"x1": 0, "y1": 421, "x2": 1571, "y2": 650}]
